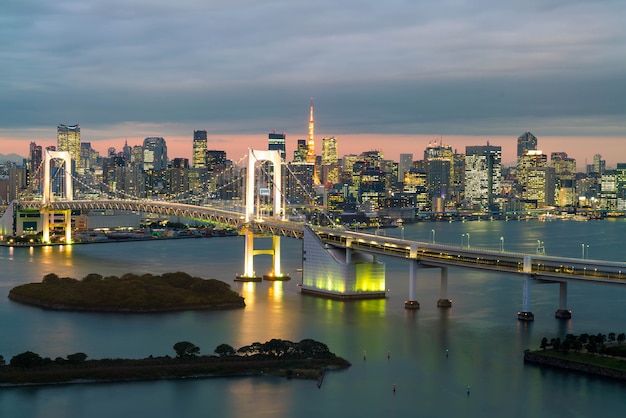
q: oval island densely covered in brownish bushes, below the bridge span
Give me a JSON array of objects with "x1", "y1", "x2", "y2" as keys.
[{"x1": 9, "y1": 272, "x2": 245, "y2": 312}]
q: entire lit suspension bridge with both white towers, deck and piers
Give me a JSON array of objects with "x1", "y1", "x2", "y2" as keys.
[{"x1": 2, "y1": 150, "x2": 626, "y2": 321}]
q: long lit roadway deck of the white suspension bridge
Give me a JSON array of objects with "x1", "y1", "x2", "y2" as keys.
[{"x1": 19, "y1": 200, "x2": 626, "y2": 285}]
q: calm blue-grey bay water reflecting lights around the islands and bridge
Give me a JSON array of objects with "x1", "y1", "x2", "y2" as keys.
[{"x1": 0, "y1": 220, "x2": 626, "y2": 418}]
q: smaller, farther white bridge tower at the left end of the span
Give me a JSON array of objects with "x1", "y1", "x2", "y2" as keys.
[{"x1": 40, "y1": 150, "x2": 74, "y2": 244}]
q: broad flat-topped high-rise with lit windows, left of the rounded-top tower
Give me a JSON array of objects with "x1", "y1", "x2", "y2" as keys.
[{"x1": 465, "y1": 144, "x2": 502, "y2": 210}]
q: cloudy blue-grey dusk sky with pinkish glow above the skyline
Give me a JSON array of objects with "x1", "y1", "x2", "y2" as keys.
[{"x1": 0, "y1": 0, "x2": 626, "y2": 166}]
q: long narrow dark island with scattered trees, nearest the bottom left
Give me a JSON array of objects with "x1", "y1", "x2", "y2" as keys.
[{"x1": 0, "y1": 339, "x2": 350, "y2": 387}]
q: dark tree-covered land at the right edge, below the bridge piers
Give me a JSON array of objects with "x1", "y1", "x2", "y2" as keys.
[{"x1": 524, "y1": 332, "x2": 626, "y2": 380}]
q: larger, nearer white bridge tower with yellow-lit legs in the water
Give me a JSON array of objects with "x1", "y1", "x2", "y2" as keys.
[{"x1": 235, "y1": 149, "x2": 290, "y2": 282}]
